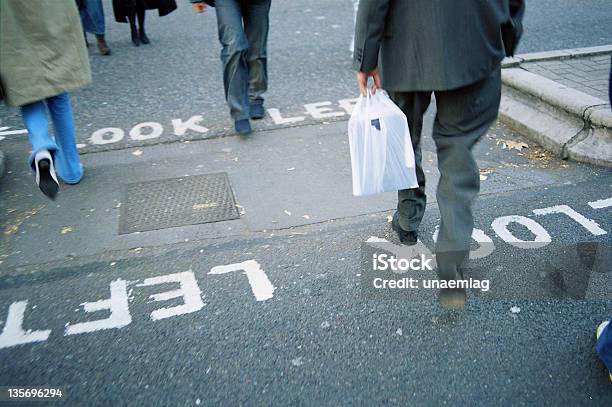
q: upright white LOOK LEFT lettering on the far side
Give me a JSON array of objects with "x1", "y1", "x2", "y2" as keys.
[{"x1": 0, "y1": 98, "x2": 357, "y2": 148}]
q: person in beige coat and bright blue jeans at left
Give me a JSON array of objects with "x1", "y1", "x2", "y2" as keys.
[{"x1": 0, "y1": 0, "x2": 91, "y2": 199}]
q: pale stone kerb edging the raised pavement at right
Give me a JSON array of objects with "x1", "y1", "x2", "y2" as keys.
[{"x1": 499, "y1": 46, "x2": 612, "y2": 167}]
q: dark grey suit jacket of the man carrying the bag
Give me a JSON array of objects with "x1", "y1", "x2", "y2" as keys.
[{"x1": 353, "y1": 0, "x2": 522, "y2": 91}]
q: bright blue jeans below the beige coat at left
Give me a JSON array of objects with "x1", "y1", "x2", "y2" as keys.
[{"x1": 21, "y1": 92, "x2": 83, "y2": 184}]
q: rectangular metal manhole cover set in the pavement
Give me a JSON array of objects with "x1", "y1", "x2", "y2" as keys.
[{"x1": 119, "y1": 172, "x2": 240, "y2": 235}]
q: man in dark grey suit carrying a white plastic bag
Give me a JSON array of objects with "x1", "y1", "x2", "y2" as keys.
[{"x1": 354, "y1": 0, "x2": 524, "y2": 308}]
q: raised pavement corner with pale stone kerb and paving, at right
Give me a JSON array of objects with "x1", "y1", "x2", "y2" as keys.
[{"x1": 500, "y1": 45, "x2": 612, "y2": 167}]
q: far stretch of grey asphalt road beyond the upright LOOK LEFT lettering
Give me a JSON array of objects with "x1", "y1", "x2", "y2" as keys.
[{"x1": 0, "y1": 0, "x2": 612, "y2": 152}]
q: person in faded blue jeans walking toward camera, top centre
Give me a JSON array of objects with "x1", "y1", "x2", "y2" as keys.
[{"x1": 190, "y1": 0, "x2": 271, "y2": 135}]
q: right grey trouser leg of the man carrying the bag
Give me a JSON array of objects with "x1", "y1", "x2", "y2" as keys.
[{"x1": 433, "y1": 68, "x2": 501, "y2": 279}]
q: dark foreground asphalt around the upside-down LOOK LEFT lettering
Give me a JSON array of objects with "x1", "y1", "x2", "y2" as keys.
[{"x1": 0, "y1": 176, "x2": 612, "y2": 406}]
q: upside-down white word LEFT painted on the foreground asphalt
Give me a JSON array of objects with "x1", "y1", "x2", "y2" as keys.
[{"x1": 0, "y1": 260, "x2": 275, "y2": 349}]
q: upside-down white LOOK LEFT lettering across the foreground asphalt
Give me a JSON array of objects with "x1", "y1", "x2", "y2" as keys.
[{"x1": 0, "y1": 197, "x2": 612, "y2": 349}]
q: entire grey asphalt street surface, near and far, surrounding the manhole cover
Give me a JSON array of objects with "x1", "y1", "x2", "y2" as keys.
[{"x1": 0, "y1": 0, "x2": 612, "y2": 406}]
